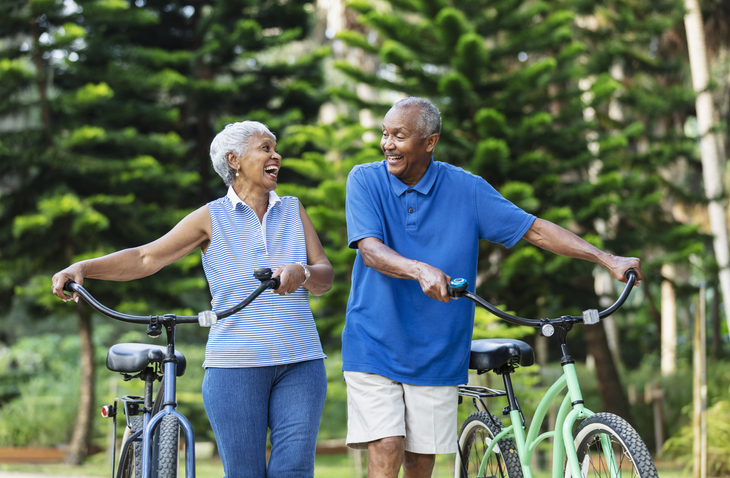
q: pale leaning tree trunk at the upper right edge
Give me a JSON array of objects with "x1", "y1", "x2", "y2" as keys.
[{"x1": 684, "y1": 0, "x2": 730, "y2": 328}]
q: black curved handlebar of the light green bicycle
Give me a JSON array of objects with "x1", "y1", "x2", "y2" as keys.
[{"x1": 448, "y1": 269, "x2": 636, "y2": 337}]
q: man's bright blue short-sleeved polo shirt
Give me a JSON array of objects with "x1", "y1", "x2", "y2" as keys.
[{"x1": 342, "y1": 159, "x2": 535, "y2": 385}]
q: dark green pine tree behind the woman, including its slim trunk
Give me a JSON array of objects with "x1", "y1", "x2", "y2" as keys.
[{"x1": 0, "y1": 0, "x2": 327, "y2": 462}]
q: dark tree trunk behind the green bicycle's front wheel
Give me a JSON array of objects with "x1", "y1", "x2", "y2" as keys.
[{"x1": 583, "y1": 322, "x2": 631, "y2": 423}]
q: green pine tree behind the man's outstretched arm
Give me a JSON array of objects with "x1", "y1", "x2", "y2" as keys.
[{"x1": 337, "y1": 0, "x2": 701, "y2": 415}]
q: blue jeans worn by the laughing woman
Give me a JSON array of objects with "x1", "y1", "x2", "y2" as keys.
[{"x1": 203, "y1": 359, "x2": 327, "y2": 478}]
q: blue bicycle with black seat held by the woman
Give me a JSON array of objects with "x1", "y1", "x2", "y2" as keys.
[{"x1": 63, "y1": 268, "x2": 280, "y2": 478}]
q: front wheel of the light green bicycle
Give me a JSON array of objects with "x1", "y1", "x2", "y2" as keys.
[{"x1": 565, "y1": 413, "x2": 658, "y2": 478}]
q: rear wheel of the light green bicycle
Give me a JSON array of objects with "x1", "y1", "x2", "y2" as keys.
[{"x1": 454, "y1": 411, "x2": 522, "y2": 478}]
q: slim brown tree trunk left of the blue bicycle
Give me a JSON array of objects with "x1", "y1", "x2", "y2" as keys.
[{"x1": 66, "y1": 304, "x2": 95, "y2": 465}]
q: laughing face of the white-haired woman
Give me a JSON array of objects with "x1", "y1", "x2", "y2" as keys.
[{"x1": 234, "y1": 133, "x2": 281, "y2": 193}]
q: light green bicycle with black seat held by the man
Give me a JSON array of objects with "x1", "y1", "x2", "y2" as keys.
[{"x1": 449, "y1": 270, "x2": 658, "y2": 478}]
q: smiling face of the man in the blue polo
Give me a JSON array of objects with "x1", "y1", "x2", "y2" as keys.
[{"x1": 380, "y1": 106, "x2": 439, "y2": 186}]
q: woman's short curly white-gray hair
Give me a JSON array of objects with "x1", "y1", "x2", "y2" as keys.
[{"x1": 210, "y1": 121, "x2": 276, "y2": 186}]
